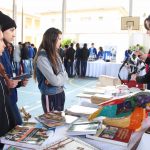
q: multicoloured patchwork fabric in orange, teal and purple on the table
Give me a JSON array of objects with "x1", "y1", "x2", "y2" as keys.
[{"x1": 89, "y1": 92, "x2": 150, "y2": 130}]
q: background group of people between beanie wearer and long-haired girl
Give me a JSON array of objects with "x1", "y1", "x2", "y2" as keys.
[{"x1": 7, "y1": 42, "x2": 37, "y2": 76}]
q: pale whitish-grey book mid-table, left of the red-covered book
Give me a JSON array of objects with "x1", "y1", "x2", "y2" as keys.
[{"x1": 67, "y1": 117, "x2": 100, "y2": 135}]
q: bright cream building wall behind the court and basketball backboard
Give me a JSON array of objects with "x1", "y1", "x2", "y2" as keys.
[{"x1": 0, "y1": 7, "x2": 148, "y2": 62}]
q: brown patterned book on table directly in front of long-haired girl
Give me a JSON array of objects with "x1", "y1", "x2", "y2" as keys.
[{"x1": 35, "y1": 113, "x2": 65, "y2": 128}]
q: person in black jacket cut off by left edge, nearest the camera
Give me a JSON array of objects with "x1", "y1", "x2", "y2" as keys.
[{"x1": 0, "y1": 26, "x2": 16, "y2": 150}]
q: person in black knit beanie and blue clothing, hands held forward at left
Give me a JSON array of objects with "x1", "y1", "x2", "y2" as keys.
[{"x1": 0, "y1": 12, "x2": 28, "y2": 125}]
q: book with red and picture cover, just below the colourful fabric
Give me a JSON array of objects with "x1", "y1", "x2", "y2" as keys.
[{"x1": 86, "y1": 126, "x2": 133, "y2": 146}]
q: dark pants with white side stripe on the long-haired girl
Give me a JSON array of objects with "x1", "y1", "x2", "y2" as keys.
[{"x1": 42, "y1": 91, "x2": 65, "y2": 113}]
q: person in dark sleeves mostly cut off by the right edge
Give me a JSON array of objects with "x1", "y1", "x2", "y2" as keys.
[{"x1": 131, "y1": 16, "x2": 150, "y2": 84}]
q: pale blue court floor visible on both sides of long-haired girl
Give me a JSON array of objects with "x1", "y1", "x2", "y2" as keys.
[{"x1": 18, "y1": 78, "x2": 97, "y2": 117}]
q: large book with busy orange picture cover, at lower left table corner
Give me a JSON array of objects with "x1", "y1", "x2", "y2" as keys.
[{"x1": 1, "y1": 126, "x2": 48, "y2": 149}]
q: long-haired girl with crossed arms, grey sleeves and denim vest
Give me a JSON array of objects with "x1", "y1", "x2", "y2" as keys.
[{"x1": 34, "y1": 28, "x2": 68, "y2": 113}]
